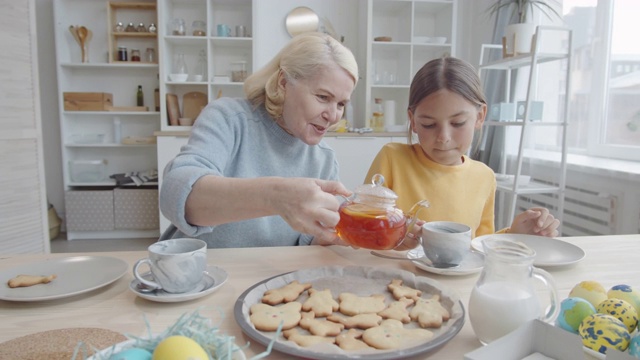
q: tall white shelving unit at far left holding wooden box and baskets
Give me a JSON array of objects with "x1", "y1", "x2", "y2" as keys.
[{"x1": 53, "y1": 0, "x2": 160, "y2": 240}]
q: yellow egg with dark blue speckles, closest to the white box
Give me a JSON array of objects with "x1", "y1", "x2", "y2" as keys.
[{"x1": 578, "y1": 314, "x2": 631, "y2": 354}]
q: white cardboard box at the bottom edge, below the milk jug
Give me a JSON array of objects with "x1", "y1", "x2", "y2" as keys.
[{"x1": 464, "y1": 320, "x2": 637, "y2": 360}]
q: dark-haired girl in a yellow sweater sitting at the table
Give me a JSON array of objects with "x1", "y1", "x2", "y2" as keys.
[{"x1": 365, "y1": 57, "x2": 560, "y2": 245}]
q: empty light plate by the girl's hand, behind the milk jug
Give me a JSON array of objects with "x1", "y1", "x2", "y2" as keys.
[{"x1": 471, "y1": 234, "x2": 585, "y2": 267}]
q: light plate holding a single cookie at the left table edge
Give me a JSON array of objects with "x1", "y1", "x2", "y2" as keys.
[{"x1": 0, "y1": 256, "x2": 129, "y2": 301}]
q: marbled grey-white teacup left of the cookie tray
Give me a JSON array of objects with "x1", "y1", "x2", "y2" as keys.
[{"x1": 133, "y1": 238, "x2": 207, "y2": 294}]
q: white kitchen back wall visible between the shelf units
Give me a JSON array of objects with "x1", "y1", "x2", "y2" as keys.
[{"x1": 36, "y1": 0, "x2": 493, "y2": 222}]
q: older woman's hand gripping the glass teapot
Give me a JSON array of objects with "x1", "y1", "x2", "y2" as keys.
[{"x1": 273, "y1": 178, "x2": 351, "y2": 245}]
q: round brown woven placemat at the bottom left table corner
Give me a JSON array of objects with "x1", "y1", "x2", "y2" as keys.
[{"x1": 0, "y1": 328, "x2": 127, "y2": 360}]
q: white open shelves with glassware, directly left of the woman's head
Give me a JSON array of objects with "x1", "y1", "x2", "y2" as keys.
[{"x1": 158, "y1": 0, "x2": 254, "y2": 131}]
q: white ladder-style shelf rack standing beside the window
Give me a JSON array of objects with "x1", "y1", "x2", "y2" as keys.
[{"x1": 479, "y1": 26, "x2": 571, "y2": 227}]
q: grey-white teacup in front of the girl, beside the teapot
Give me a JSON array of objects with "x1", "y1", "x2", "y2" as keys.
[{"x1": 421, "y1": 221, "x2": 471, "y2": 268}]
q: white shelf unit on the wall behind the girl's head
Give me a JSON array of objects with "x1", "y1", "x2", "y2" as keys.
[{"x1": 356, "y1": 0, "x2": 458, "y2": 126}]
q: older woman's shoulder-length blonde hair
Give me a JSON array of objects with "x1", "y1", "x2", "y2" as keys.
[{"x1": 244, "y1": 32, "x2": 358, "y2": 119}]
